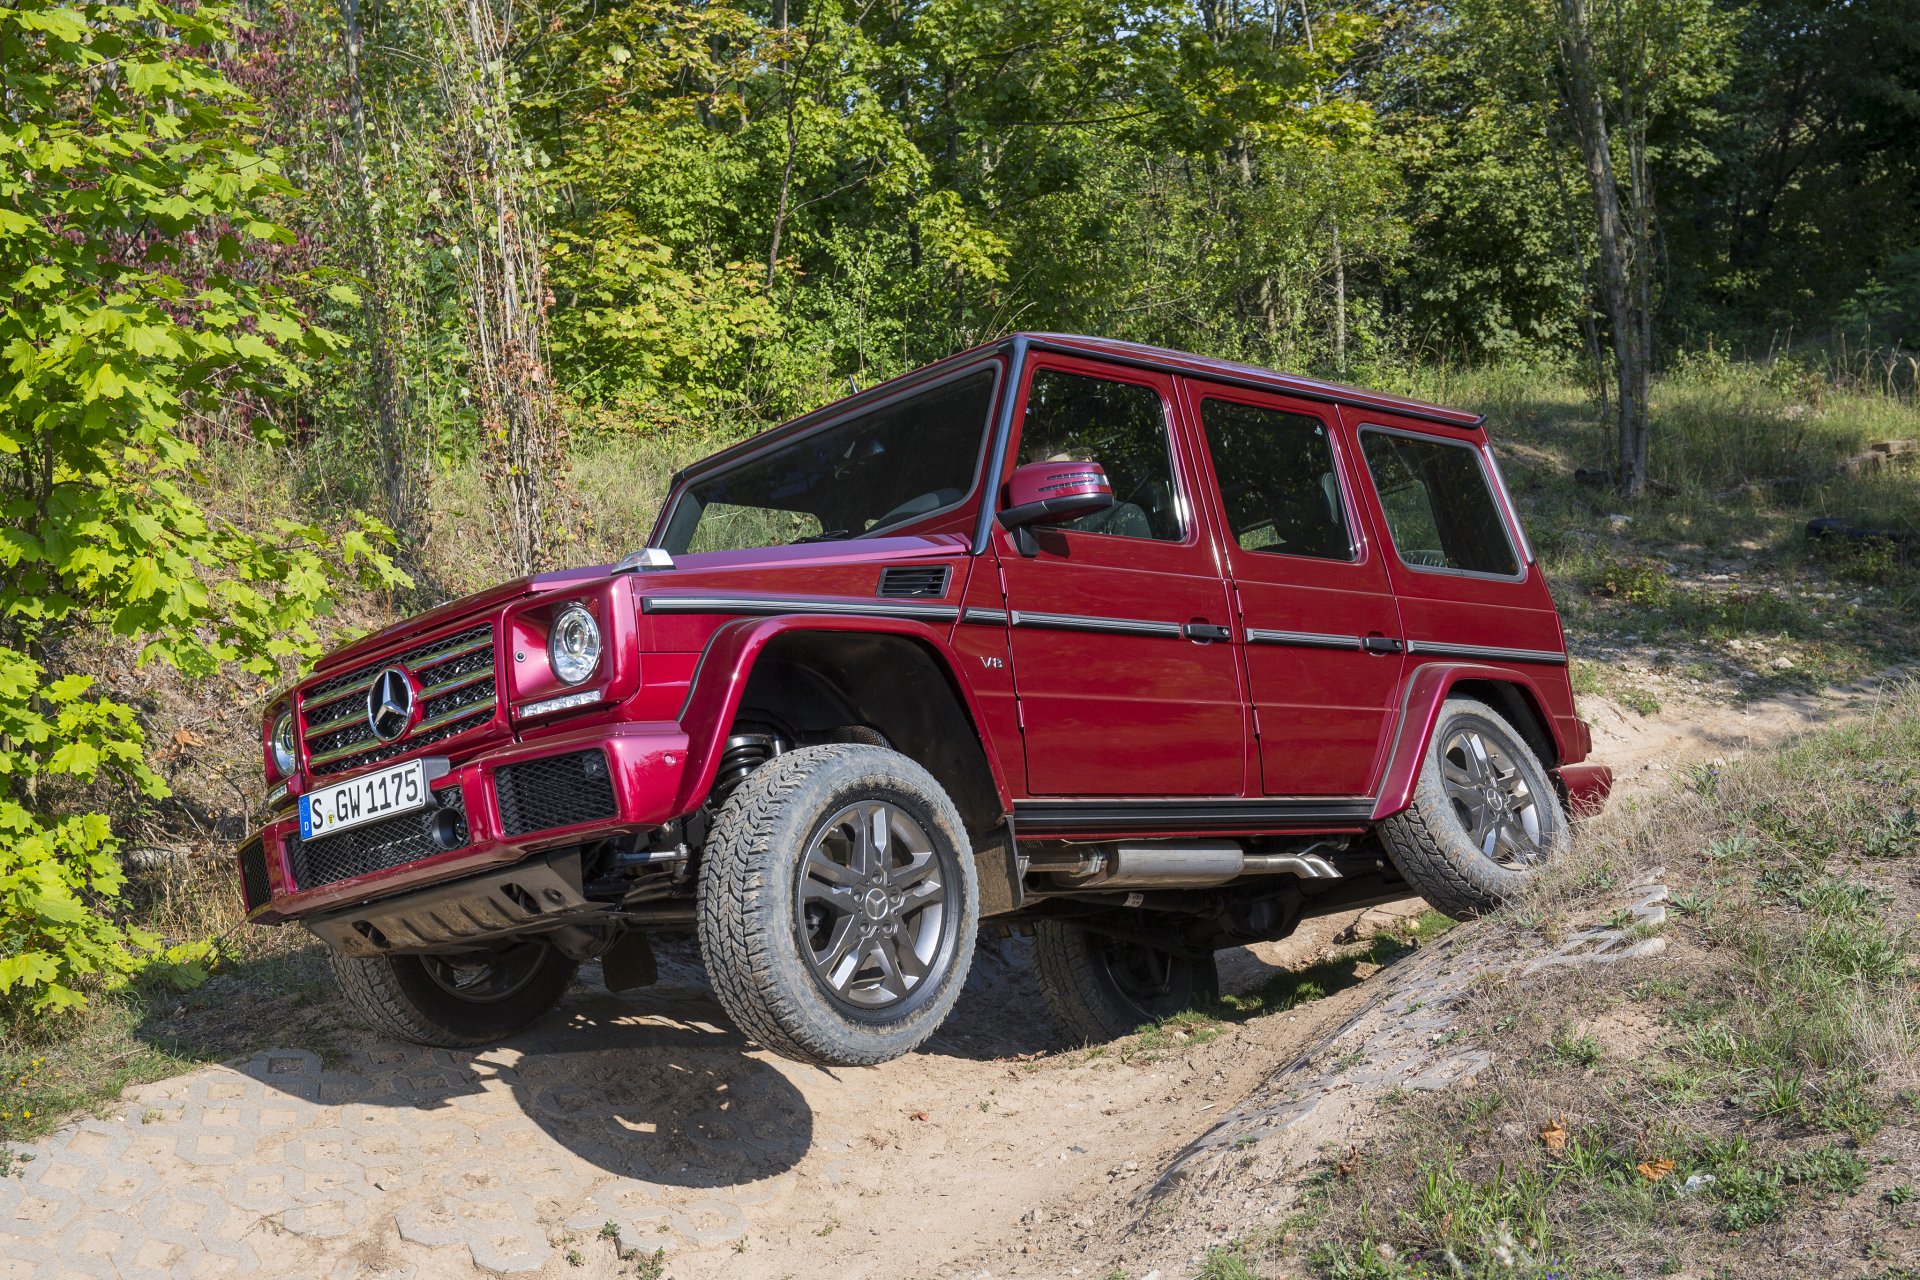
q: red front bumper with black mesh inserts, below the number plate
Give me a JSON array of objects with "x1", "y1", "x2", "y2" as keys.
[{"x1": 240, "y1": 723, "x2": 687, "y2": 923}]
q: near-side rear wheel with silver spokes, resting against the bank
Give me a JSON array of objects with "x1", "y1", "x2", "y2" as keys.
[{"x1": 1380, "y1": 699, "x2": 1567, "y2": 919}]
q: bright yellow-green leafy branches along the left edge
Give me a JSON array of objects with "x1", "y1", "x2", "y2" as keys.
[{"x1": 0, "y1": 0, "x2": 405, "y2": 1011}]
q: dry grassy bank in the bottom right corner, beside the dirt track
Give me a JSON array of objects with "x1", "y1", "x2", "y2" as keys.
[{"x1": 1274, "y1": 689, "x2": 1920, "y2": 1280}]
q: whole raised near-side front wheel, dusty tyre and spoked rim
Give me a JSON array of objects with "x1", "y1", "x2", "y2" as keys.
[{"x1": 699, "y1": 743, "x2": 979, "y2": 1067}]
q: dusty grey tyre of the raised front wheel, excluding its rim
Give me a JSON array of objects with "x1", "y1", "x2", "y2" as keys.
[{"x1": 699, "y1": 743, "x2": 979, "y2": 1067}]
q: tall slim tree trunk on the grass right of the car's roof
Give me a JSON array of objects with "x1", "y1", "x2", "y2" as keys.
[{"x1": 1557, "y1": 0, "x2": 1651, "y2": 497}]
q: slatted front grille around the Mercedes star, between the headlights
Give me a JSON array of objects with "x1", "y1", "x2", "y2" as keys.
[{"x1": 300, "y1": 624, "x2": 499, "y2": 775}]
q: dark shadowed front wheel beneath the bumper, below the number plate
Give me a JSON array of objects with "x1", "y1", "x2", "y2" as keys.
[{"x1": 332, "y1": 938, "x2": 578, "y2": 1048}]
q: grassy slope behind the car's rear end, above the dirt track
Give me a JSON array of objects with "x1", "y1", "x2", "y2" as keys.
[{"x1": 1404, "y1": 355, "x2": 1920, "y2": 716}]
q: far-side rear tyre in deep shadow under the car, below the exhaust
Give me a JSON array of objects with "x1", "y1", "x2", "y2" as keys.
[{"x1": 1033, "y1": 919, "x2": 1219, "y2": 1044}]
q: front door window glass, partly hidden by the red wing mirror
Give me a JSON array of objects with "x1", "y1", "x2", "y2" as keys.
[{"x1": 1020, "y1": 368, "x2": 1185, "y2": 543}]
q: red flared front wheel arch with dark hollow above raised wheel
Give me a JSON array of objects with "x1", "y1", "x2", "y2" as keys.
[{"x1": 678, "y1": 614, "x2": 1012, "y2": 833}]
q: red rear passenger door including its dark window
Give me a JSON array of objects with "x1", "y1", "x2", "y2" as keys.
[{"x1": 1185, "y1": 380, "x2": 1402, "y2": 796}]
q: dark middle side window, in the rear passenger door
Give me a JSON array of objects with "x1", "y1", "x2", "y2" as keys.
[{"x1": 1200, "y1": 399, "x2": 1354, "y2": 560}]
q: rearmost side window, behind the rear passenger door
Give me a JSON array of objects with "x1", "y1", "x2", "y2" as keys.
[{"x1": 1359, "y1": 430, "x2": 1521, "y2": 578}]
